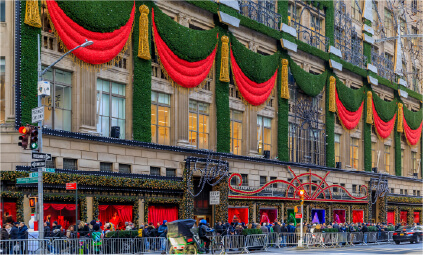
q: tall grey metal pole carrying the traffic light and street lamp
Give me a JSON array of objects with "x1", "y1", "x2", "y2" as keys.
[{"x1": 37, "y1": 34, "x2": 44, "y2": 239}]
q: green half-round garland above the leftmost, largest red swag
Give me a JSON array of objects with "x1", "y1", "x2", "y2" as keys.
[{"x1": 57, "y1": 0, "x2": 133, "y2": 32}]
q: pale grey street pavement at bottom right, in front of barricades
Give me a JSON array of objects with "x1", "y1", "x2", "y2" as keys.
[{"x1": 262, "y1": 243, "x2": 423, "y2": 255}]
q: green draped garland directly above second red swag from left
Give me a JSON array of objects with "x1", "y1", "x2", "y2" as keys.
[{"x1": 153, "y1": 4, "x2": 218, "y2": 62}]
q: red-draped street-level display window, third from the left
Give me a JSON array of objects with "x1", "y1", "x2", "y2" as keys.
[{"x1": 98, "y1": 205, "x2": 133, "y2": 229}]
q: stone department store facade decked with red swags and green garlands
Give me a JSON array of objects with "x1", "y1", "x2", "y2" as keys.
[{"x1": 0, "y1": 0, "x2": 423, "y2": 225}]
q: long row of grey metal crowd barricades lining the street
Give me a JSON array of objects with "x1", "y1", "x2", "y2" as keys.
[{"x1": 0, "y1": 231, "x2": 394, "y2": 254}]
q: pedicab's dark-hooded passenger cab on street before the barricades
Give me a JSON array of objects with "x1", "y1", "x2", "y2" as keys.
[{"x1": 167, "y1": 219, "x2": 204, "y2": 254}]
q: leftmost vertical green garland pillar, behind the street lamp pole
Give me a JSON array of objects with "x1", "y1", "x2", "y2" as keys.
[{"x1": 20, "y1": 1, "x2": 41, "y2": 125}]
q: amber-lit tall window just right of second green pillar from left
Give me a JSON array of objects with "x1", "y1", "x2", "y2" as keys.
[{"x1": 151, "y1": 91, "x2": 170, "y2": 145}]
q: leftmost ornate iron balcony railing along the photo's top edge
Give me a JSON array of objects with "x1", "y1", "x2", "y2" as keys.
[{"x1": 238, "y1": 0, "x2": 282, "y2": 30}]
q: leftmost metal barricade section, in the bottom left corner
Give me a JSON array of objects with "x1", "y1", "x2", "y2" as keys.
[{"x1": 0, "y1": 239, "x2": 50, "y2": 254}]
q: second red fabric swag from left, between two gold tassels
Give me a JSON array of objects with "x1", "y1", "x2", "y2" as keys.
[{"x1": 151, "y1": 8, "x2": 217, "y2": 88}]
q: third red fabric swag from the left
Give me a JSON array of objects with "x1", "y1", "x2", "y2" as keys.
[{"x1": 231, "y1": 49, "x2": 278, "y2": 106}]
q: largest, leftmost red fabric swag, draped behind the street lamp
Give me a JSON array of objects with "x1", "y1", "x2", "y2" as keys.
[{"x1": 47, "y1": 0, "x2": 135, "y2": 65}]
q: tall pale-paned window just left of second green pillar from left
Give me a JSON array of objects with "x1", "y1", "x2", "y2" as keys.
[{"x1": 97, "y1": 79, "x2": 125, "y2": 139}]
